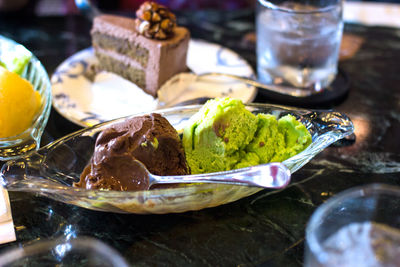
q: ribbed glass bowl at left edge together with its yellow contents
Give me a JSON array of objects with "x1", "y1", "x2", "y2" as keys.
[{"x1": 0, "y1": 35, "x2": 51, "y2": 161}]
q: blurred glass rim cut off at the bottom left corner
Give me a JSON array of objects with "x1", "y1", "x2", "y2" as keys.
[{"x1": 0, "y1": 237, "x2": 129, "y2": 267}]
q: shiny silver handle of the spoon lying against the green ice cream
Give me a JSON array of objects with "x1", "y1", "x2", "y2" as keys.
[{"x1": 153, "y1": 163, "x2": 290, "y2": 188}]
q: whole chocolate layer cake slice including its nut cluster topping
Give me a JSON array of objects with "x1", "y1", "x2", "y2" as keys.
[{"x1": 91, "y1": 2, "x2": 190, "y2": 97}]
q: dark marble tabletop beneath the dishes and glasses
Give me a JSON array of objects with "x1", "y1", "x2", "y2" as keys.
[{"x1": 0, "y1": 10, "x2": 400, "y2": 266}]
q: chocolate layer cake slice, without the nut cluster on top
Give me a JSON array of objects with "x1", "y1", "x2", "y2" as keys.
[{"x1": 91, "y1": 15, "x2": 190, "y2": 97}]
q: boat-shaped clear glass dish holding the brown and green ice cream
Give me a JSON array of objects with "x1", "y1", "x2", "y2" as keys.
[{"x1": 0, "y1": 104, "x2": 353, "y2": 214}]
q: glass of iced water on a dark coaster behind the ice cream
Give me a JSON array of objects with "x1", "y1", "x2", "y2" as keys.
[{"x1": 256, "y1": 0, "x2": 343, "y2": 96}]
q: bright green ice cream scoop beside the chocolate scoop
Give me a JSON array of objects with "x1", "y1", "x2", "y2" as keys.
[{"x1": 182, "y1": 98, "x2": 311, "y2": 174}]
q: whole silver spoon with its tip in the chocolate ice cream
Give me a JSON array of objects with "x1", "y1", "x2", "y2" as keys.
[{"x1": 122, "y1": 160, "x2": 290, "y2": 190}]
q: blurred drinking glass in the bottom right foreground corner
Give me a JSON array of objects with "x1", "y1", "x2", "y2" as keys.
[{"x1": 305, "y1": 184, "x2": 400, "y2": 267}]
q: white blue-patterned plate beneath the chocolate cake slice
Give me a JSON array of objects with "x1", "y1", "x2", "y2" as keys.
[{"x1": 51, "y1": 40, "x2": 257, "y2": 127}]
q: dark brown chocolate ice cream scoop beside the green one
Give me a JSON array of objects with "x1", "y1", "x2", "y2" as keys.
[{"x1": 75, "y1": 113, "x2": 188, "y2": 191}]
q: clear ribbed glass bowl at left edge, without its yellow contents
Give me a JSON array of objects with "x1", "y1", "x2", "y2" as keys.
[{"x1": 0, "y1": 35, "x2": 51, "y2": 160}]
